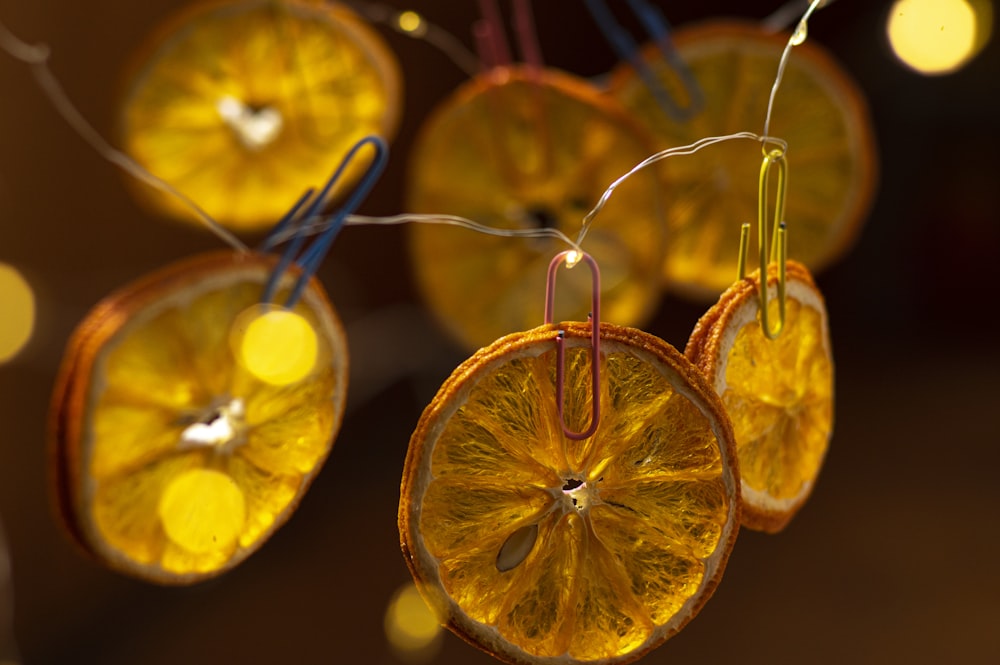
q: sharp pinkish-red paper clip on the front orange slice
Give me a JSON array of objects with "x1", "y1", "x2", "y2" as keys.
[{"x1": 545, "y1": 249, "x2": 601, "y2": 441}]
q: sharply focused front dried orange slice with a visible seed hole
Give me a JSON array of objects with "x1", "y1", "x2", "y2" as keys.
[{"x1": 399, "y1": 323, "x2": 740, "y2": 665}]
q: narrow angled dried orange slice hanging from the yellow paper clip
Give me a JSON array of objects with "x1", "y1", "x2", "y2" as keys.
[{"x1": 685, "y1": 261, "x2": 834, "y2": 532}]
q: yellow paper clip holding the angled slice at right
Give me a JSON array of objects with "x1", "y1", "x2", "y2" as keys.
[{"x1": 738, "y1": 148, "x2": 788, "y2": 340}]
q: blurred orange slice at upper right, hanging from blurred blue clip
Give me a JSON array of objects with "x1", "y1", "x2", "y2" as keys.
[{"x1": 611, "y1": 21, "x2": 877, "y2": 299}]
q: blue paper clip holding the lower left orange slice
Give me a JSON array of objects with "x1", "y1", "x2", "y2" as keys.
[{"x1": 261, "y1": 136, "x2": 389, "y2": 308}]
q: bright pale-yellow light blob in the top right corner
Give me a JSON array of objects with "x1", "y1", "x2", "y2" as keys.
[{"x1": 886, "y1": 0, "x2": 977, "y2": 74}]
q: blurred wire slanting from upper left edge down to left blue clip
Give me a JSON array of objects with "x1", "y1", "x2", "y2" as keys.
[{"x1": 0, "y1": 22, "x2": 250, "y2": 252}]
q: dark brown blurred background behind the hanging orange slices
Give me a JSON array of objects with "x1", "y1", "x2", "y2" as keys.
[{"x1": 0, "y1": 0, "x2": 1000, "y2": 665}]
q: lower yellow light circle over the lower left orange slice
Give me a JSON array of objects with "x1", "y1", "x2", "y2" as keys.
[{"x1": 157, "y1": 469, "x2": 246, "y2": 554}]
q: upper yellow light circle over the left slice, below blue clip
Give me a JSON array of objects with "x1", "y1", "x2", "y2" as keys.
[{"x1": 237, "y1": 308, "x2": 319, "y2": 386}]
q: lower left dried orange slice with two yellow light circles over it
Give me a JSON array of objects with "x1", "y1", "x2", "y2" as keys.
[{"x1": 52, "y1": 252, "x2": 347, "y2": 584}]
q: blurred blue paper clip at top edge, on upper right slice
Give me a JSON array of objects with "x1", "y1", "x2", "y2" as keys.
[{"x1": 584, "y1": 0, "x2": 704, "y2": 122}]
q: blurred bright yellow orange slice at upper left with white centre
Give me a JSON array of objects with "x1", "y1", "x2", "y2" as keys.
[{"x1": 119, "y1": 0, "x2": 401, "y2": 231}]
